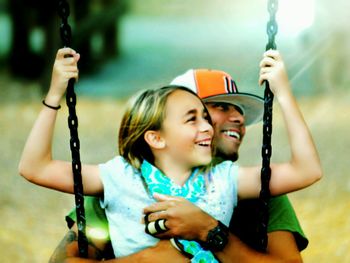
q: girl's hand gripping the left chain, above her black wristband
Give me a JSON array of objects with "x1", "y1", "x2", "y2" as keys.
[{"x1": 45, "y1": 48, "x2": 80, "y2": 105}]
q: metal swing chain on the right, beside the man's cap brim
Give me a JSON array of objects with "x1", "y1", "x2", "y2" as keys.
[{"x1": 257, "y1": 0, "x2": 278, "y2": 251}]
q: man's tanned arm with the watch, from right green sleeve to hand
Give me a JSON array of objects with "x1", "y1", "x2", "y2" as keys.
[{"x1": 144, "y1": 195, "x2": 302, "y2": 262}]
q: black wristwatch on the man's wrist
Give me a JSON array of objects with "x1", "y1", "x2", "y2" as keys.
[{"x1": 202, "y1": 221, "x2": 229, "y2": 252}]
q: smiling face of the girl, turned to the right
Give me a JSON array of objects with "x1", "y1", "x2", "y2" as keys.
[{"x1": 160, "y1": 90, "x2": 214, "y2": 168}]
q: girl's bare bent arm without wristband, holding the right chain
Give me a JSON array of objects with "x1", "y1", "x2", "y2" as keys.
[{"x1": 238, "y1": 50, "x2": 322, "y2": 198}]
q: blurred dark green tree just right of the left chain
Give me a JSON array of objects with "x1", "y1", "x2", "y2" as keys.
[{"x1": 71, "y1": 0, "x2": 126, "y2": 70}]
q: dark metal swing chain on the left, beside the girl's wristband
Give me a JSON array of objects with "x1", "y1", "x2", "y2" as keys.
[{"x1": 58, "y1": 0, "x2": 88, "y2": 258}]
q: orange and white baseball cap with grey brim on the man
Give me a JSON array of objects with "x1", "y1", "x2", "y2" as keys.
[{"x1": 170, "y1": 69, "x2": 264, "y2": 125}]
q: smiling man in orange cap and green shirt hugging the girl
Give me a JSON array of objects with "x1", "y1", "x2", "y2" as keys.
[{"x1": 50, "y1": 70, "x2": 308, "y2": 262}]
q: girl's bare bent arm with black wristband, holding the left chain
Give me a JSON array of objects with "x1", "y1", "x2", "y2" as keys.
[{"x1": 19, "y1": 48, "x2": 103, "y2": 194}]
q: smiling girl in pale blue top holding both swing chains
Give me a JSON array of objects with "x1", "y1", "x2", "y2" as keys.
[{"x1": 19, "y1": 48, "x2": 322, "y2": 257}]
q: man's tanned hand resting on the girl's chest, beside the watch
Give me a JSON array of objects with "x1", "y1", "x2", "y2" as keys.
[{"x1": 143, "y1": 194, "x2": 218, "y2": 241}]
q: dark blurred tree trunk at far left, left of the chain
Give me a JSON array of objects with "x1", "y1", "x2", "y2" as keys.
[{"x1": 8, "y1": 0, "x2": 57, "y2": 78}]
